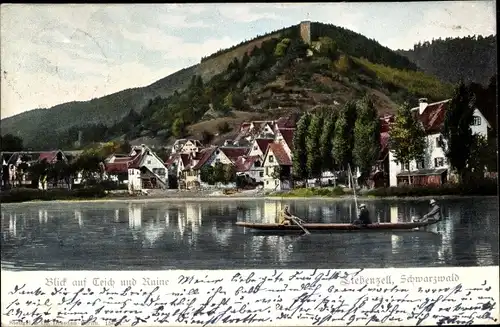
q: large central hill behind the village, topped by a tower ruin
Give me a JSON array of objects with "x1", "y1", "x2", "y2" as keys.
[{"x1": 1, "y1": 23, "x2": 451, "y2": 150}]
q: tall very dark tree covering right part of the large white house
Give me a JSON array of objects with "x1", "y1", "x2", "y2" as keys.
[{"x1": 442, "y1": 82, "x2": 474, "y2": 182}]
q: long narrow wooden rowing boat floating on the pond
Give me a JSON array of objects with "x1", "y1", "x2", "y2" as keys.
[{"x1": 236, "y1": 220, "x2": 438, "y2": 232}]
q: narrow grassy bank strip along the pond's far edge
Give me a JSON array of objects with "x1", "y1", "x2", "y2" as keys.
[{"x1": 0, "y1": 184, "x2": 497, "y2": 204}]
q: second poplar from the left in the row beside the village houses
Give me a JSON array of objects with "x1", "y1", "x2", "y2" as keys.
[{"x1": 306, "y1": 114, "x2": 323, "y2": 178}]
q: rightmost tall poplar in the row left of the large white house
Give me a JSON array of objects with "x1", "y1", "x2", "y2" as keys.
[{"x1": 353, "y1": 96, "x2": 380, "y2": 187}]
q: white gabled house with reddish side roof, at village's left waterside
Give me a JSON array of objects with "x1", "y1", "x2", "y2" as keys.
[{"x1": 105, "y1": 145, "x2": 168, "y2": 192}]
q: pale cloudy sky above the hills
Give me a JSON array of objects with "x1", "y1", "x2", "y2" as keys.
[{"x1": 0, "y1": 1, "x2": 496, "y2": 118}]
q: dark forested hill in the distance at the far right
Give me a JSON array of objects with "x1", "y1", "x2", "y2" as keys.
[{"x1": 398, "y1": 35, "x2": 497, "y2": 85}]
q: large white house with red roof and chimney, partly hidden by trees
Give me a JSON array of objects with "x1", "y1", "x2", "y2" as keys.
[{"x1": 389, "y1": 99, "x2": 491, "y2": 186}]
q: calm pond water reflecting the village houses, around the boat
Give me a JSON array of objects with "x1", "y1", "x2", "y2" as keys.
[{"x1": 1, "y1": 197, "x2": 499, "y2": 270}]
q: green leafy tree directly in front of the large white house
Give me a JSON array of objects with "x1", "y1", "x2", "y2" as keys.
[{"x1": 389, "y1": 103, "x2": 426, "y2": 184}]
